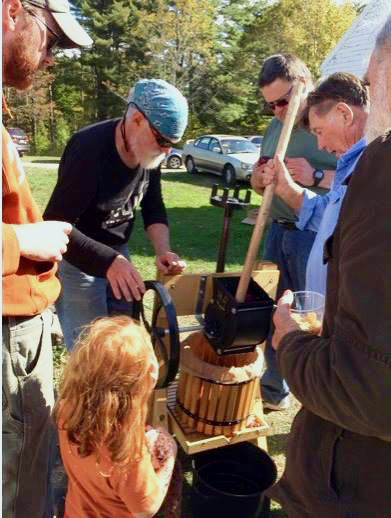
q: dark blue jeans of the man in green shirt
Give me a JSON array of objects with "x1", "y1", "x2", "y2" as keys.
[{"x1": 261, "y1": 222, "x2": 316, "y2": 404}]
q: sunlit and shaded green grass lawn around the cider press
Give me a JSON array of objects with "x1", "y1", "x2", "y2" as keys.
[{"x1": 27, "y1": 165, "x2": 290, "y2": 518}]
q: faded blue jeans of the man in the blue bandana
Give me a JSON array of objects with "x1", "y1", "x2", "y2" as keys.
[{"x1": 56, "y1": 245, "x2": 132, "y2": 351}]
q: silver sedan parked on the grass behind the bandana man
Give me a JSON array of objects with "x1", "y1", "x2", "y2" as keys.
[{"x1": 183, "y1": 135, "x2": 259, "y2": 185}]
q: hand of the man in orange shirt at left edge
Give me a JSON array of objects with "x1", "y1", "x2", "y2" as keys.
[{"x1": 12, "y1": 221, "x2": 72, "y2": 262}]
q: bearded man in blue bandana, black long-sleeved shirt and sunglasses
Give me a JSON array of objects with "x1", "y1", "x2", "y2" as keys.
[{"x1": 44, "y1": 79, "x2": 188, "y2": 349}]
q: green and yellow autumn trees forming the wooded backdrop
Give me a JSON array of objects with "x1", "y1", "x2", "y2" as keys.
[{"x1": 4, "y1": 0, "x2": 360, "y2": 154}]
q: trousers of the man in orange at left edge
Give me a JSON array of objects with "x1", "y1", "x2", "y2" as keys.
[{"x1": 2, "y1": 310, "x2": 54, "y2": 518}]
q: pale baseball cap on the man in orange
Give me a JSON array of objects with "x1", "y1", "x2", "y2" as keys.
[{"x1": 23, "y1": 0, "x2": 93, "y2": 49}]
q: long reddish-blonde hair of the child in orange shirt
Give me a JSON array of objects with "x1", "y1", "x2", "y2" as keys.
[{"x1": 54, "y1": 316, "x2": 155, "y2": 466}]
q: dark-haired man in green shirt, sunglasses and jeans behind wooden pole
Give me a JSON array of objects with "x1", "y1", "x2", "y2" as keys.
[{"x1": 251, "y1": 54, "x2": 336, "y2": 410}]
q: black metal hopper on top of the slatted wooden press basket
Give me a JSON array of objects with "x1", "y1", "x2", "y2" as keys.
[{"x1": 205, "y1": 277, "x2": 274, "y2": 354}]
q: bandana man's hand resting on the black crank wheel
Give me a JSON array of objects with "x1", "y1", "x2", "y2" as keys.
[{"x1": 106, "y1": 255, "x2": 145, "y2": 302}]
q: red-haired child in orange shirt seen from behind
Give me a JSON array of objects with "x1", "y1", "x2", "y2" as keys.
[{"x1": 55, "y1": 316, "x2": 176, "y2": 518}]
